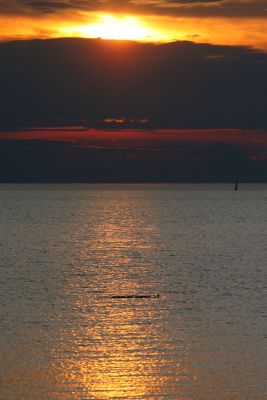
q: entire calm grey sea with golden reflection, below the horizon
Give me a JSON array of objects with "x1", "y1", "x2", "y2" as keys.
[{"x1": 0, "y1": 184, "x2": 267, "y2": 400}]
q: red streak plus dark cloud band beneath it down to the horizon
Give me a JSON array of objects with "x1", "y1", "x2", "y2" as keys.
[{"x1": 0, "y1": 130, "x2": 267, "y2": 182}]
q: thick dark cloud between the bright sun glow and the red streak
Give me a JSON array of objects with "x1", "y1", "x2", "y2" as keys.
[{"x1": 0, "y1": 39, "x2": 267, "y2": 129}]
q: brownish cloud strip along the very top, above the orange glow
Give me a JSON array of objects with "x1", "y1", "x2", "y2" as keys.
[{"x1": 0, "y1": 0, "x2": 267, "y2": 18}]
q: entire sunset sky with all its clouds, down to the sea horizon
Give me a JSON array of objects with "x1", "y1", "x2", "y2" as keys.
[{"x1": 0, "y1": 0, "x2": 267, "y2": 182}]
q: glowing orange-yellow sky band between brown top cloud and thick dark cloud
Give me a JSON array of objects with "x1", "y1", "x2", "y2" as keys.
[{"x1": 0, "y1": 12, "x2": 267, "y2": 51}]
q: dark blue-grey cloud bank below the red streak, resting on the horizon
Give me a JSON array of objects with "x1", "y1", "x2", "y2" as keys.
[{"x1": 0, "y1": 139, "x2": 267, "y2": 183}]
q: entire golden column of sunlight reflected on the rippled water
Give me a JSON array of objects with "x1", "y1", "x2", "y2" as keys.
[{"x1": 52, "y1": 195, "x2": 191, "y2": 399}]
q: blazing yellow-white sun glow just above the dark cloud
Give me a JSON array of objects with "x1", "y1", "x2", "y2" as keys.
[{"x1": 67, "y1": 15, "x2": 161, "y2": 41}]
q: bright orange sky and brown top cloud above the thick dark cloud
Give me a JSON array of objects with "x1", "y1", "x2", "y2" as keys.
[{"x1": 0, "y1": 0, "x2": 267, "y2": 50}]
